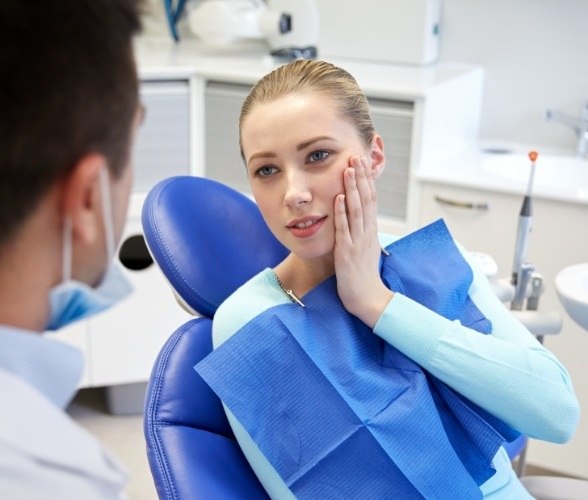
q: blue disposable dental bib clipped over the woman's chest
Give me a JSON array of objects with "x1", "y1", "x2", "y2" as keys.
[{"x1": 196, "y1": 221, "x2": 518, "y2": 500}]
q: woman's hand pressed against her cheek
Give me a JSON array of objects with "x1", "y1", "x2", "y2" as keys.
[{"x1": 334, "y1": 156, "x2": 393, "y2": 328}]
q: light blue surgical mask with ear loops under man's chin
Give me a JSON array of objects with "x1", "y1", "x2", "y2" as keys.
[{"x1": 46, "y1": 168, "x2": 133, "y2": 330}]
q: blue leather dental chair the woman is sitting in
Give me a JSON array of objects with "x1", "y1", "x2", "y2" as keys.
[{"x1": 142, "y1": 176, "x2": 588, "y2": 500}]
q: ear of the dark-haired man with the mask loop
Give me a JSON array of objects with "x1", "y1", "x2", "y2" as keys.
[{"x1": 63, "y1": 153, "x2": 107, "y2": 244}]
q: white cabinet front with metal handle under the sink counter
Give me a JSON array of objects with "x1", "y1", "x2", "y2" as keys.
[{"x1": 420, "y1": 183, "x2": 588, "y2": 292}]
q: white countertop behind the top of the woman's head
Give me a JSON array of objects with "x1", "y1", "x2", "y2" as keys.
[{"x1": 135, "y1": 37, "x2": 483, "y2": 101}]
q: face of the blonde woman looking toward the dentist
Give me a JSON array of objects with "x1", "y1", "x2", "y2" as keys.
[{"x1": 241, "y1": 94, "x2": 382, "y2": 266}]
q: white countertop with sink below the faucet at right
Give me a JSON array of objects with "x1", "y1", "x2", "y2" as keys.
[{"x1": 416, "y1": 144, "x2": 588, "y2": 206}]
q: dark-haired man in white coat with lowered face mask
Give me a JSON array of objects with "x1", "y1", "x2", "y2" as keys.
[{"x1": 0, "y1": 0, "x2": 142, "y2": 499}]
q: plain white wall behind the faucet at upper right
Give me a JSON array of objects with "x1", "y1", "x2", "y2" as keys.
[{"x1": 440, "y1": 0, "x2": 588, "y2": 151}]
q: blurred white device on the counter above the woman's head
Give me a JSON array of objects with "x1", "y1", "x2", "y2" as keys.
[{"x1": 188, "y1": 0, "x2": 319, "y2": 58}]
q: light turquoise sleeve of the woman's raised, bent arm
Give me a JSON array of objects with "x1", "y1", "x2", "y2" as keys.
[{"x1": 374, "y1": 244, "x2": 579, "y2": 443}]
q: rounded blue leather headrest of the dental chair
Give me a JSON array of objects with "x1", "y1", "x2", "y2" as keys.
[{"x1": 142, "y1": 176, "x2": 288, "y2": 318}]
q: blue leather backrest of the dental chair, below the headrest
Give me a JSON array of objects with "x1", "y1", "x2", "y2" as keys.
[{"x1": 144, "y1": 318, "x2": 267, "y2": 500}]
